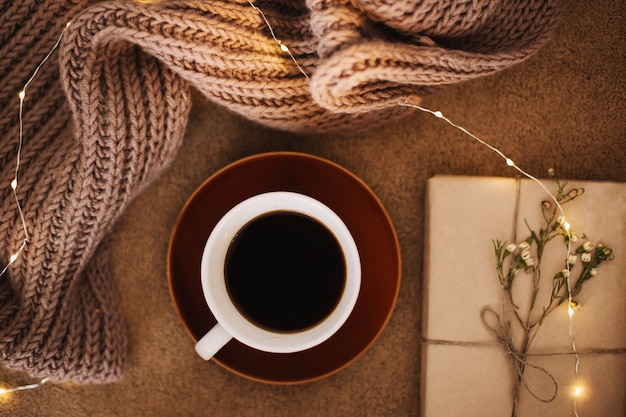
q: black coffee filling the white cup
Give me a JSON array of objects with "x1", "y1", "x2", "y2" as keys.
[{"x1": 224, "y1": 211, "x2": 346, "y2": 332}]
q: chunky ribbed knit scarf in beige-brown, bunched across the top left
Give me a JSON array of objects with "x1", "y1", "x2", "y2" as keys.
[{"x1": 0, "y1": 0, "x2": 558, "y2": 383}]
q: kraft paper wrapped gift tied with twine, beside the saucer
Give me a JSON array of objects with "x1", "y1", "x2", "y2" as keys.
[{"x1": 422, "y1": 176, "x2": 626, "y2": 417}]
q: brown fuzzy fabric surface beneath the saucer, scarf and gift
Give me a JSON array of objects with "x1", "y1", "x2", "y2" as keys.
[{"x1": 0, "y1": 0, "x2": 626, "y2": 417}]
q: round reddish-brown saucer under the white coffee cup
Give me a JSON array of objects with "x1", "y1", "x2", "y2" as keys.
[{"x1": 167, "y1": 152, "x2": 400, "y2": 384}]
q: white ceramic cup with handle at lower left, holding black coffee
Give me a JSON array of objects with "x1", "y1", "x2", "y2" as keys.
[{"x1": 195, "y1": 191, "x2": 361, "y2": 360}]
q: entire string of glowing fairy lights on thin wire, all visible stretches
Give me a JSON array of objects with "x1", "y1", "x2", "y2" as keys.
[{"x1": 0, "y1": 0, "x2": 604, "y2": 417}]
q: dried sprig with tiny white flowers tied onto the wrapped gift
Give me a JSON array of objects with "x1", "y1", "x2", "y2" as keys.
[{"x1": 493, "y1": 177, "x2": 613, "y2": 416}]
